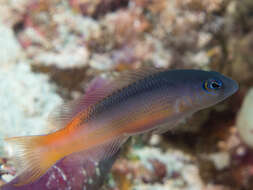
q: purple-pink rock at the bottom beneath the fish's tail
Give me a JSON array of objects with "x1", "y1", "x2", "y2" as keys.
[{"x1": 0, "y1": 153, "x2": 117, "y2": 190}]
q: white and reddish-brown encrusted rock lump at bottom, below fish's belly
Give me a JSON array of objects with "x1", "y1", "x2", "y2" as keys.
[{"x1": 112, "y1": 147, "x2": 203, "y2": 190}]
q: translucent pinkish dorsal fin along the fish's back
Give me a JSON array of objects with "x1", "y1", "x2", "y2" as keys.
[{"x1": 48, "y1": 67, "x2": 164, "y2": 132}]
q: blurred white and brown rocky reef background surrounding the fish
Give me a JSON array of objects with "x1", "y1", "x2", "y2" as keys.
[{"x1": 0, "y1": 0, "x2": 253, "y2": 190}]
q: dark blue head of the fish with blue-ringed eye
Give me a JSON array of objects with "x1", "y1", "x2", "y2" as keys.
[{"x1": 161, "y1": 70, "x2": 238, "y2": 110}]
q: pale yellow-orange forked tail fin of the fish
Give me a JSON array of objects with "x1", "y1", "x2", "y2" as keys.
[{"x1": 5, "y1": 136, "x2": 61, "y2": 186}]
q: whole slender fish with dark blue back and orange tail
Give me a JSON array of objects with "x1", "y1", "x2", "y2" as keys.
[{"x1": 5, "y1": 68, "x2": 238, "y2": 186}]
